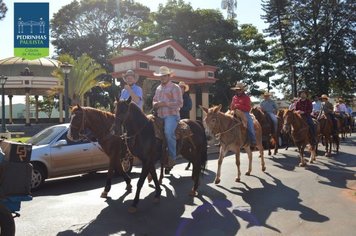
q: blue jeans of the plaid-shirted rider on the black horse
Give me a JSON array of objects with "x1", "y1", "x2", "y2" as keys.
[{"x1": 162, "y1": 115, "x2": 180, "y2": 160}]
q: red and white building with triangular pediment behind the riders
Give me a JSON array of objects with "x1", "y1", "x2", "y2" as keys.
[{"x1": 110, "y1": 39, "x2": 217, "y2": 119}]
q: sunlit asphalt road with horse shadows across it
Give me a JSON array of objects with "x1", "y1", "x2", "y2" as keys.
[{"x1": 15, "y1": 134, "x2": 356, "y2": 236}]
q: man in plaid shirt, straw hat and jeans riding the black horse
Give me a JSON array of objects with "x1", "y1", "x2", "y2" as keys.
[{"x1": 152, "y1": 66, "x2": 183, "y2": 170}]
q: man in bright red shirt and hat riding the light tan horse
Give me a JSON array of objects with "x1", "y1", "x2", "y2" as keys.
[{"x1": 230, "y1": 82, "x2": 256, "y2": 148}]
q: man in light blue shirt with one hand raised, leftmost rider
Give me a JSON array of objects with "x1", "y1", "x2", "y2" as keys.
[{"x1": 119, "y1": 70, "x2": 143, "y2": 110}]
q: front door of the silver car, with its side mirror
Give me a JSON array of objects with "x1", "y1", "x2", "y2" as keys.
[{"x1": 50, "y1": 132, "x2": 101, "y2": 176}]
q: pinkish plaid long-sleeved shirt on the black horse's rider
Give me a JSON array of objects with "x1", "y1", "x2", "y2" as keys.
[{"x1": 153, "y1": 81, "x2": 183, "y2": 118}]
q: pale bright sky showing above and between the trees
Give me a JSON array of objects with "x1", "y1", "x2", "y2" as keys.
[{"x1": 0, "y1": 0, "x2": 266, "y2": 104}]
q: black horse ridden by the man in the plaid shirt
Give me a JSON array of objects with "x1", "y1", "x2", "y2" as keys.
[{"x1": 115, "y1": 97, "x2": 207, "y2": 212}]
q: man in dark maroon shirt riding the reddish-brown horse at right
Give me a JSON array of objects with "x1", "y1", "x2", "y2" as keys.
[{"x1": 295, "y1": 90, "x2": 316, "y2": 145}]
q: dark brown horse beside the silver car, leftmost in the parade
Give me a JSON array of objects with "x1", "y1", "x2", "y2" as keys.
[{"x1": 67, "y1": 105, "x2": 132, "y2": 198}]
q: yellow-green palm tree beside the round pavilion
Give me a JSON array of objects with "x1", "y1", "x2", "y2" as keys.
[{"x1": 50, "y1": 54, "x2": 110, "y2": 105}]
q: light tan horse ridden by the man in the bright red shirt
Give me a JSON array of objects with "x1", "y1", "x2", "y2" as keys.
[{"x1": 200, "y1": 104, "x2": 266, "y2": 184}]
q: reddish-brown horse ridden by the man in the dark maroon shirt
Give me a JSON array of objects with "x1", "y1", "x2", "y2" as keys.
[{"x1": 283, "y1": 110, "x2": 317, "y2": 167}]
